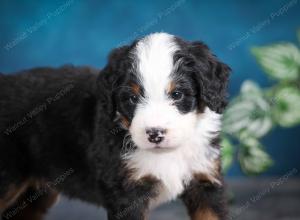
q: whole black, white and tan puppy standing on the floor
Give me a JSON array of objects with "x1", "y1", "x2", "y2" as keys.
[{"x1": 0, "y1": 33, "x2": 230, "y2": 220}]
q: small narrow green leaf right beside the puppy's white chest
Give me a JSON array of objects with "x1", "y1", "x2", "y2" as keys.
[{"x1": 221, "y1": 137, "x2": 234, "y2": 173}]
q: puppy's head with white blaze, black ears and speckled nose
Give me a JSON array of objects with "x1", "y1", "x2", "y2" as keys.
[{"x1": 100, "y1": 33, "x2": 230, "y2": 150}]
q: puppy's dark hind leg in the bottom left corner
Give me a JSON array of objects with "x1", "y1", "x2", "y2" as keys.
[{"x1": 2, "y1": 186, "x2": 58, "y2": 220}]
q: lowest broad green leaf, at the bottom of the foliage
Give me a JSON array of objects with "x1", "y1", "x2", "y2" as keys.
[{"x1": 238, "y1": 137, "x2": 273, "y2": 175}]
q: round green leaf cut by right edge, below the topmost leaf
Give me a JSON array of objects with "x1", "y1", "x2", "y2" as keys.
[{"x1": 272, "y1": 87, "x2": 300, "y2": 127}]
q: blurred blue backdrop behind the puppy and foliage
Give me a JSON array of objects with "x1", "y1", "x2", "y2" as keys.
[{"x1": 0, "y1": 0, "x2": 300, "y2": 176}]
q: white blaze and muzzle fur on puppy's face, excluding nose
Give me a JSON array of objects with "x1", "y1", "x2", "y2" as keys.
[{"x1": 130, "y1": 33, "x2": 196, "y2": 149}]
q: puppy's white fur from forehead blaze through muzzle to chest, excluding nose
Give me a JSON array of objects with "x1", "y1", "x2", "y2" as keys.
[{"x1": 125, "y1": 33, "x2": 221, "y2": 209}]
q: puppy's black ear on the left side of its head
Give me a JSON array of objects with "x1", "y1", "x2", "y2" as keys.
[{"x1": 97, "y1": 46, "x2": 130, "y2": 118}]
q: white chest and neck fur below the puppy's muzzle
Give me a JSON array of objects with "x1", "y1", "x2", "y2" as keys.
[{"x1": 126, "y1": 109, "x2": 221, "y2": 207}]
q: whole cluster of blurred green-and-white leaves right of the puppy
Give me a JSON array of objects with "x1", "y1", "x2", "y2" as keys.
[{"x1": 221, "y1": 30, "x2": 300, "y2": 175}]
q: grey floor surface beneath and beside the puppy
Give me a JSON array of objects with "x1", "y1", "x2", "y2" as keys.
[{"x1": 39, "y1": 179, "x2": 300, "y2": 220}]
